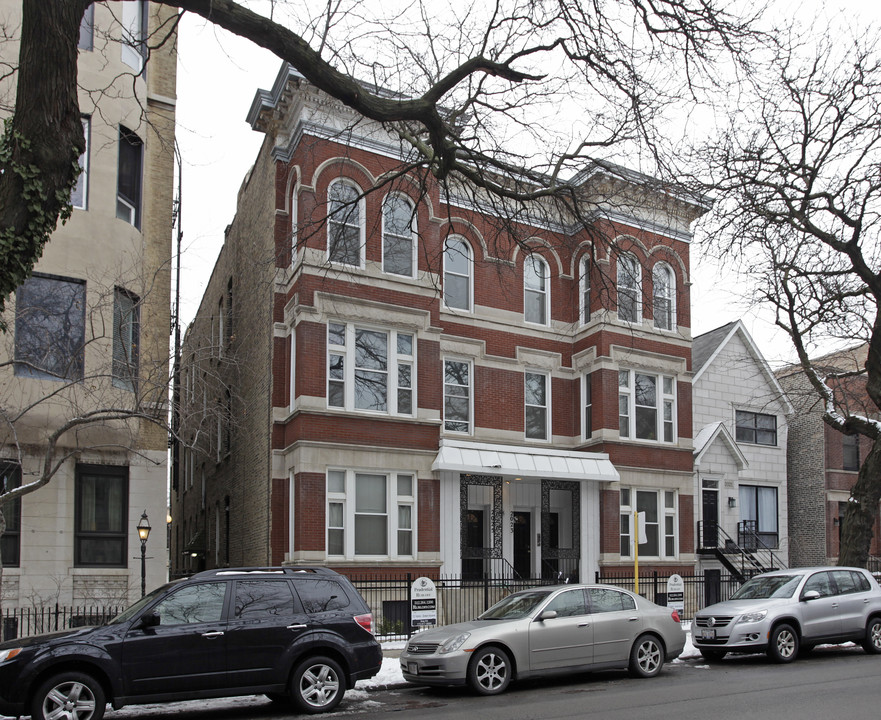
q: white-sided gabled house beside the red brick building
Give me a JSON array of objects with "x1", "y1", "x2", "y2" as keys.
[{"x1": 692, "y1": 321, "x2": 792, "y2": 574}]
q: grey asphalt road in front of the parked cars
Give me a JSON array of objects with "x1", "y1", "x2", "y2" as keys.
[{"x1": 107, "y1": 647, "x2": 881, "y2": 720}]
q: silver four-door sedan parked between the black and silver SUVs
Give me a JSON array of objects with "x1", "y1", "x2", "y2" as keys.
[{"x1": 401, "y1": 585, "x2": 685, "y2": 695}]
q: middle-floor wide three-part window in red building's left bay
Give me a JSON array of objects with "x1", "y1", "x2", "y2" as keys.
[{"x1": 327, "y1": 323, "x2": 416, "y2": 415}]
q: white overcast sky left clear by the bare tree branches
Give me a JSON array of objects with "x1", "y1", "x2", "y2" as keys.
[{"x1": 177, "y1": 0, "x2": 881, "y2": 363}]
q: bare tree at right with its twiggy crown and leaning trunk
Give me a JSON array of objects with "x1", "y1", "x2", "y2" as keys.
[{"x1": 702, "y1": 34, "x2": 881, "y2": 566}]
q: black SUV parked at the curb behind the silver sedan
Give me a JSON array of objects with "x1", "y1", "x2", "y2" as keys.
[{"x1": 0, "y1": 567, "x2": 382, "y2": 720}]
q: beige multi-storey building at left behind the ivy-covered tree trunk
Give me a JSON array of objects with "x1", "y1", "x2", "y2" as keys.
[{"x1": 0, "y1": 0, "x2": 177, "y2": 608}]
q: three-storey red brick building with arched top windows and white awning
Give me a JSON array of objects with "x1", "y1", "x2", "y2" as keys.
[{"x1": 172, "y1": 66, "x2": 706, "y2": 578}]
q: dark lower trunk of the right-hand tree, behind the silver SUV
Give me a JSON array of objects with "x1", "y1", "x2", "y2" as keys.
[{"x1": 838, "y1": 440, "x2": 881, "y2": 567}]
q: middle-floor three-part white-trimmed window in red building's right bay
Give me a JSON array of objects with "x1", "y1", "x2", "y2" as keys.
[{"x1": 618, "y1": 370, "x2": 676, "y2": 443}]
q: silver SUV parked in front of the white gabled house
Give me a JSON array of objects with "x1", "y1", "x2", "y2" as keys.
[{"x1": 691, "y1": 567, "x2": 881, "y2": 663}]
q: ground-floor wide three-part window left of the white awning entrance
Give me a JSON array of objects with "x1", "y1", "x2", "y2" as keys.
[{"x1": 327, "y1": 470, "x2": 416, "y2": 559}]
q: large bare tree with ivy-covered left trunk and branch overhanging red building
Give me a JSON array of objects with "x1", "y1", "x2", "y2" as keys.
[{"x1": 0, "y1": 0, "x2": 754, "y2": 311}]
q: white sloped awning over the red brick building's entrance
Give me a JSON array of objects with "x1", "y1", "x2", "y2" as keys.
[{"x1": 431, "y1": 440, "x2": 620, "y2": 482}]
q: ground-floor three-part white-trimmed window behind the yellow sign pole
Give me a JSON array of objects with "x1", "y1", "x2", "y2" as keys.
[{"x1": 620, "y1": 488, "x2": 679, "y2": 559}]
